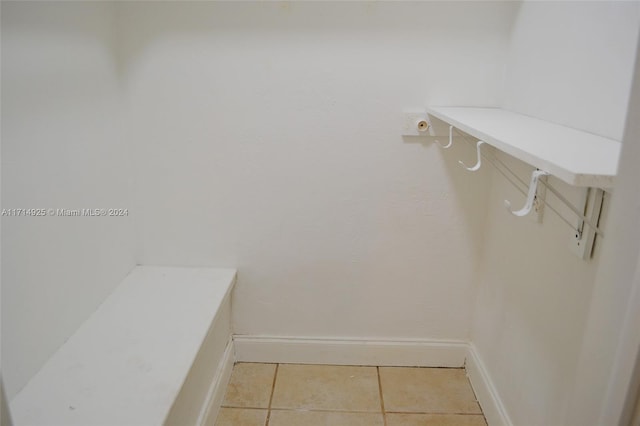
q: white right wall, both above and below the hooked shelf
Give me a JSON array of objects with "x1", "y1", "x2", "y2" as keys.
[{"x1": 472, "y1": 2, "x2": 639, "y2": 425}]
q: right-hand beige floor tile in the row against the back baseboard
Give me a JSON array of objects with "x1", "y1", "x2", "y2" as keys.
[{"x1": 380, "y1": 367, "x2": 482, "y2": 414}]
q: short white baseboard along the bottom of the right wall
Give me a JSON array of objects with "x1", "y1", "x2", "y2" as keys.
[{"x1": 465, "y1": 343, "x2": 513, "y2": 426}]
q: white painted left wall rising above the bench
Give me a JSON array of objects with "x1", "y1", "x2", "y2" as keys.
[{"x1": 1, "y1": 2, "x2": 134, "y2": 399}]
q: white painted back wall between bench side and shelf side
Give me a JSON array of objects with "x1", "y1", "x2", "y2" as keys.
[{"x1": 120, "y1": 2, "x2": 517, "y2": 339}]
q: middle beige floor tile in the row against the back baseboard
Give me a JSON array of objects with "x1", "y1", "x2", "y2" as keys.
[{"x1": 271, "y1": 364, "x2": 381, "y2": 412}]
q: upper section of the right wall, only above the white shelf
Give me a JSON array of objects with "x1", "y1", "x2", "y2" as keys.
[{"x1": 504, "y1": 1, "x2": 640, "y2": 140}]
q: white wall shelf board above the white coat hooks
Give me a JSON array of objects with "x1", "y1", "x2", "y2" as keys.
[{"x1": 427, "y1": 107, "x2": 621, "y2": 188}]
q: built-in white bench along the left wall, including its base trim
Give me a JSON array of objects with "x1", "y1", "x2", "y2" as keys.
[{"x1": 11, "y1": 266, "x2": 236, "y2": 426}]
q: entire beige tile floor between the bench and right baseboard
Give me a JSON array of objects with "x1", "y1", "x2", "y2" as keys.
[{"x1": 216, "y1": 363, "x2": 486, "y2": 426}]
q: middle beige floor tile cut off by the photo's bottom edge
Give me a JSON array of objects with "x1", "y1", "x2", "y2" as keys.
[{"x1": 269, "y1": 410, "x2": 384, "y2": 426}]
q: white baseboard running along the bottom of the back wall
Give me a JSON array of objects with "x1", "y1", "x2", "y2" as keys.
[{"x1": 233, "y1": 335, "x2": 468, "y2": 367}]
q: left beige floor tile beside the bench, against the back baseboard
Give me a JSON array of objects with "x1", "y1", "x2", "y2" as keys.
[{"x1": 222, "y1": 362, "x2": 276, "y2": 408}]
